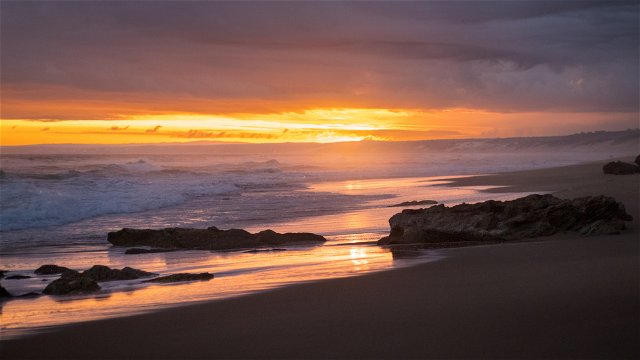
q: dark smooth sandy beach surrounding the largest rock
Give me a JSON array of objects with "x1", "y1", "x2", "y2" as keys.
[{"x1": 0, "y1": 159, "x2": 640, "y2": 359}]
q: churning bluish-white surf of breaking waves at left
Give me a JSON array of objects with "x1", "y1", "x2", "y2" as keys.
[{"x1": 0, "y1": 159, "x2": 296, "y2": 231}]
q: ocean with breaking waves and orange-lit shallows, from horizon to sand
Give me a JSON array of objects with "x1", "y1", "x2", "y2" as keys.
[{"x1": 0, "y1": 131, "x2": 638, "y2": 338}]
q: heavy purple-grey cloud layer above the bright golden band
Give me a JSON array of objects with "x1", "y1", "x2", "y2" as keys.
[{"x1": 1, "y1": 1, "x2": 639, "y2": 116}]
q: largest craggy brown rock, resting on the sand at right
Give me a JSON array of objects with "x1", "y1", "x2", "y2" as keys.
[{"x1": 378, "y1": 195, "x2": 632, "y2": 245}]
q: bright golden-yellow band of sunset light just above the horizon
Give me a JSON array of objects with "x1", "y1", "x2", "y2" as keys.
[{"x1": 0, "y1": 108, "x2": 631, "y2": 145}]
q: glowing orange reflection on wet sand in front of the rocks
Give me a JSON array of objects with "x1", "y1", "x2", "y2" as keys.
[{"x1": 0, "y1": 235, "x2": 420, "y2": 338}]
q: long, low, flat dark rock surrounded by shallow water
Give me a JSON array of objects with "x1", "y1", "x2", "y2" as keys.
[{"x1": 107, "y1": 226, "x2": 326, "y2": 250}]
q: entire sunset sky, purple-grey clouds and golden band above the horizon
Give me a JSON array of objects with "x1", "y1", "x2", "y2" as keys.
[{"x1": 0, "y1": 0, "x2": 640, "y2": 145}]
